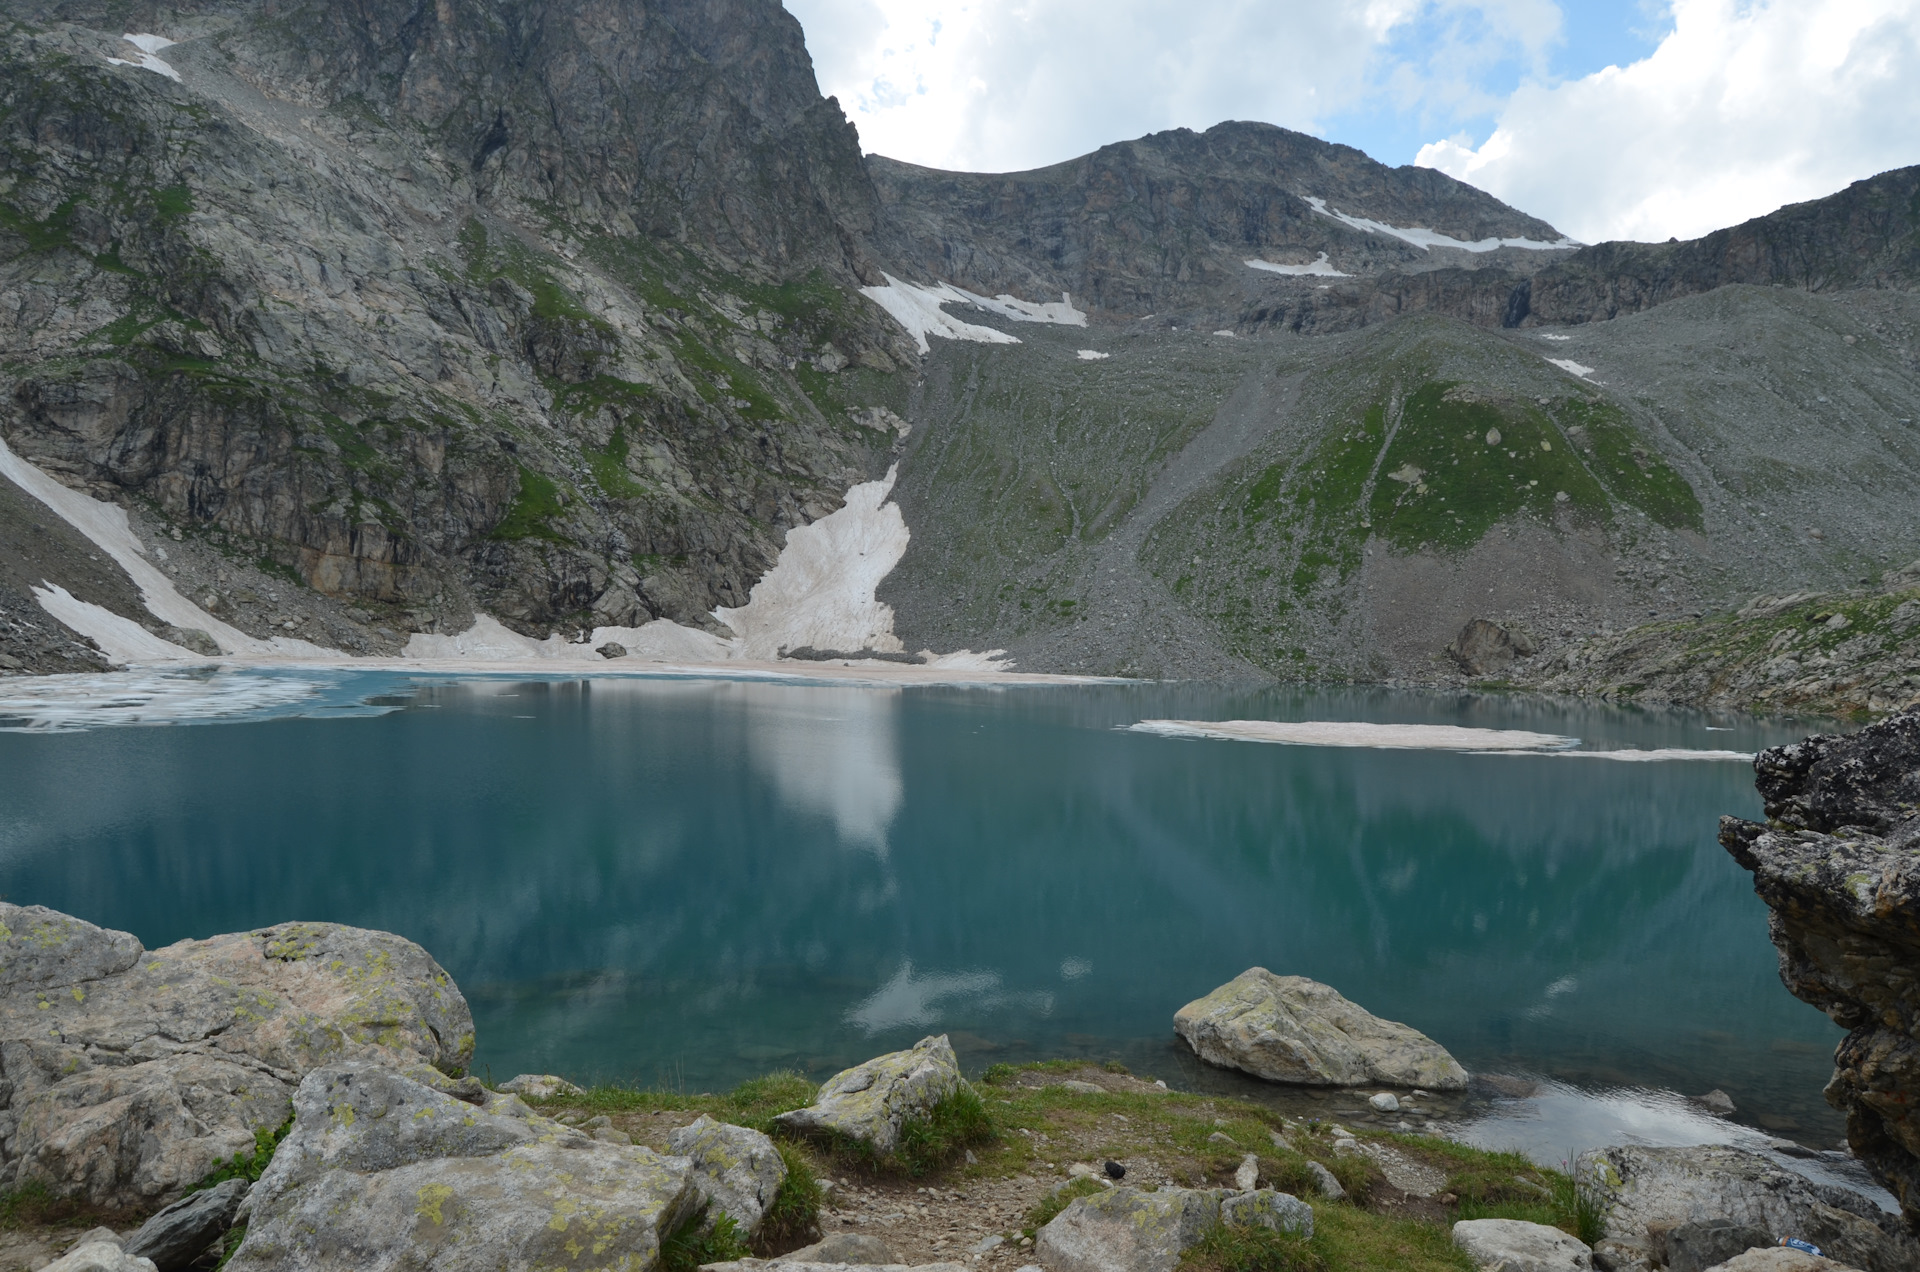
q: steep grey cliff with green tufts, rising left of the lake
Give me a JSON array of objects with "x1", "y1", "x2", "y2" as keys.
[{"x1": 0, "y1": 0, "x2": 910, "y2": 648}]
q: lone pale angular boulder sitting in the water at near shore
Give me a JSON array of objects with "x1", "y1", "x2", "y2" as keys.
[{"x1": 1173, "y1": 966, "x2": 1467, "y2": 1091}]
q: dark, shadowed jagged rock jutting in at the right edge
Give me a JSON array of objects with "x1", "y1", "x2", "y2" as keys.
[{"x1": 1720, "y1": 711, "x2": 1920, "y2": 1226}]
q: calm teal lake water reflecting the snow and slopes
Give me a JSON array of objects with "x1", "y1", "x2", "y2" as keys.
[{"x1": 0, "y1": 673, "x2": 1841, "y2": 1153}]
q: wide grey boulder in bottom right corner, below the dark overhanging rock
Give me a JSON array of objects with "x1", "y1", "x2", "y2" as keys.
[{"x1": 1580, "y1": 1145, "x2": 1920, "y2": 1272}]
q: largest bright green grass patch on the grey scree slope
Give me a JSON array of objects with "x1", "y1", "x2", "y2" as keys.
[{"x1": 1367, "y1": 380, "x2": 1609, "y2": 548}]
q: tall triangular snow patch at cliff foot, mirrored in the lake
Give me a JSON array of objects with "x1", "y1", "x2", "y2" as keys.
[{"x1": 714, "y1": 465, "x2": 908, "y2": 659}]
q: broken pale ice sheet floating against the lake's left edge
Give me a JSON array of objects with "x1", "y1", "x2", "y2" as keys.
[{"x1": 0, "y1": 669, "x2": 397, "y2": 734}]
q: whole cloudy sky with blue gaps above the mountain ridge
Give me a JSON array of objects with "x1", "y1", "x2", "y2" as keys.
[{"x1": 785, "y1": 0, "x2": 1920, "y2": 242}]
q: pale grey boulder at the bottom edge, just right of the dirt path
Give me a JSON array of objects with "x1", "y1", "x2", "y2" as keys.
[{"x1": 1033, "y1": 1187, "x2": 1221, "y2": 1272}]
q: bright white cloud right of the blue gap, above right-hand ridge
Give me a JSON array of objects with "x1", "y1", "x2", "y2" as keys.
[{"x1": 1417, "y1": 0, "x2": 1920, "y2": 242}]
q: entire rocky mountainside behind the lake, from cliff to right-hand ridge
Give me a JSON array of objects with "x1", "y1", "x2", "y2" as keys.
[{"x1": 0, "y1": 0, "x2": 1920, "y2": 691}]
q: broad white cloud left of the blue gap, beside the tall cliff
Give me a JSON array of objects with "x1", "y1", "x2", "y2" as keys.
[{"x1": 785, "y1": 0, "x2": 1561, "y2": 171}]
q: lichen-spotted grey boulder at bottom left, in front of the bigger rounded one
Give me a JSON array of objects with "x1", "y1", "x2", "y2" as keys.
[{"x1": 227, "y1": 1063, "x2": 701, "y2": 1272}]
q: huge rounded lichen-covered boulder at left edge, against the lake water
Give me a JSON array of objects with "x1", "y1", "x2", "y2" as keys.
[{"x1": 0, "y1": 903, "x2": 474, "y2": 1209}]
